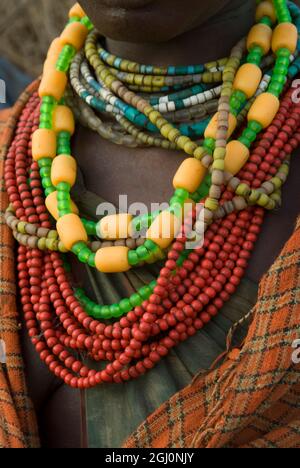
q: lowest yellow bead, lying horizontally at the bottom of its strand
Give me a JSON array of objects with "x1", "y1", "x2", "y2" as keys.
[{"x1": 95, "y1": 247, "x2": 131, "y2": 273}]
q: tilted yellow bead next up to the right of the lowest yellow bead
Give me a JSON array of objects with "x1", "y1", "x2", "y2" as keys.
[{"x1": 146, "y1": 211, "x2": 180, "y2": 249}]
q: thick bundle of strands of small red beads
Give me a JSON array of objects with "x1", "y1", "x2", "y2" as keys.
[{"x1": 5, "y1": 82, "x2": 300, "y2": 388}]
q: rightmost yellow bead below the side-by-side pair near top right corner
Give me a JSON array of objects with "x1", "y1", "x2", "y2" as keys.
[{"x1": 248, "y1": 93, "x2": 280, "y2": 128}]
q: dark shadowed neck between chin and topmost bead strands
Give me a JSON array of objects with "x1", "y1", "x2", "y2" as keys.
[{"x1": 106, "y1": 0, "x2": 255, "y2": 66}]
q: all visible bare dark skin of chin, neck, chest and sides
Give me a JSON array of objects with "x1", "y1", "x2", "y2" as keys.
[{"x1": 23, "y1": 0, "x2": 300, "y2": 447}]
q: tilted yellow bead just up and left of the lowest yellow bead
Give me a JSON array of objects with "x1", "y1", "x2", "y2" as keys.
[{"x1": 56, "y1": 214, "x2": 88, "y2": 250}]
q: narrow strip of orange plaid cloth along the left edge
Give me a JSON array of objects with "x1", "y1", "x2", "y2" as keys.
[{"x1": 0, "y1": 84, "x2": 39, "y2": 448}]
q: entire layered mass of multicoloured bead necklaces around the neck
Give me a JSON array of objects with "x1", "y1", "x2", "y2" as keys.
[{"x1": 5, "y1": 0, "x2": 300, "y2": 388}]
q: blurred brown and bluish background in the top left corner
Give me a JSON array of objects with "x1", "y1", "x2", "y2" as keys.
[{"x1": 0, "y1": 0, "x2": 300, "y2": 110}]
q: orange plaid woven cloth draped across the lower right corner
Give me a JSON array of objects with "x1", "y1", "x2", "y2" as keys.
[{"x1": 125, "y1": 220, "x2": 300, "y2": 448}]
